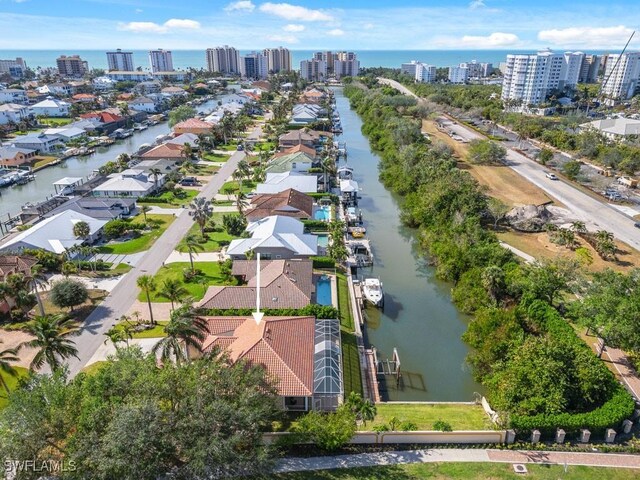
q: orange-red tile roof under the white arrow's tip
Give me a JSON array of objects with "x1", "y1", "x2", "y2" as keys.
[{"x1": 196, "y1": 317, "x2": 315, "y2": 397}]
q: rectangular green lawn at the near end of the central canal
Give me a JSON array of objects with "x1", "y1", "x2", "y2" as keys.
[{"x1": 360, "y1": 403, "x2": 491, "y2": 430}]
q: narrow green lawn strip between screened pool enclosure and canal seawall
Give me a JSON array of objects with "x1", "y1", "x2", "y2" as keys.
[{"x1": 337, "y1": 273, "x2": 362, "y2": 395}]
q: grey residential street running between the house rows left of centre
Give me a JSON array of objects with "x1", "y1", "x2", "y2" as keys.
[{"x1": 69, "y1": 152, "x2": 245, "y2": 376}]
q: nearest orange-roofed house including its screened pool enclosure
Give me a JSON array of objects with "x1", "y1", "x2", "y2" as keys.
[{"x1": 189, "y1": 317, "x2": 343, "y2": 411}]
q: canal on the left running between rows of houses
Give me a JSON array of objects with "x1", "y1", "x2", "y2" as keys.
[{"x1": 0, "y1": 96, "x2": 224, "y2": 219}]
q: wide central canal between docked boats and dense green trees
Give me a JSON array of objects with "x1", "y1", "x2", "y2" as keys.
[{"x1": 334, "y1": 88, "x2": 482, "y2": 401}]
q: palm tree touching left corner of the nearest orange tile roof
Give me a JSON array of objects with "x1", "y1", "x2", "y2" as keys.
[{"x1": 152, "y1": 305, "x2": 209, "y2": 364}]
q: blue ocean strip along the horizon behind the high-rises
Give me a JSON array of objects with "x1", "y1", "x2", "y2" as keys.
[{"x1": 0, "y1": 48, "x2": 607, "y2": 70}]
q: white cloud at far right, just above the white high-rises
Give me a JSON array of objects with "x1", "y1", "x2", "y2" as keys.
[{"x1": 538, "y1": 25, "x2": 633, "y2": 48}]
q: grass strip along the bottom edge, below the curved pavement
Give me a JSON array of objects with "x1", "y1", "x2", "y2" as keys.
[{"x1": 262, "y1": 462, "x2": 638, "y2": 480}]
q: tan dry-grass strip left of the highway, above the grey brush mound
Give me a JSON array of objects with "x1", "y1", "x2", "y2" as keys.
[{"x1": 422, "y1": 120, "x2": 559, "y2": 206}]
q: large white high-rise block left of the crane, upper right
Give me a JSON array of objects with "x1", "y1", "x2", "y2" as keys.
[{"x1": 502, "y1": 49, "x2": 584, "y2": 105}]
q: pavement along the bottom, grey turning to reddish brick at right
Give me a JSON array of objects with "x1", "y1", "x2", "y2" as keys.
[{"x1": 274, "y1": 448, "x2": 640, "y2": 473}]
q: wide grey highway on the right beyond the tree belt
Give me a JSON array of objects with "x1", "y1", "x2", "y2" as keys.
[{"x1": 380, "y1": 79, "x2": 640, "y2": 250}]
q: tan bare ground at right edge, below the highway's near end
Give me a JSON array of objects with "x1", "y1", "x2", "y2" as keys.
[{"x1": 498, "y1": 231, "x2": 640, "y2": 272}]
